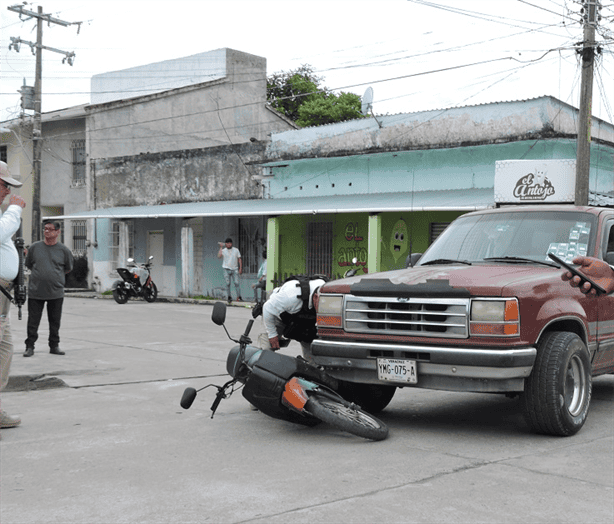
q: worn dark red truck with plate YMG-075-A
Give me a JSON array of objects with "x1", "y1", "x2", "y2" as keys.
[{"x1": 311, "y1": 205, "x2": 614, "y2": 436}]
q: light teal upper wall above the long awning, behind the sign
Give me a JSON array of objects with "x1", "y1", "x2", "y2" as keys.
[{"x1": 270, "y1": 139, "x2": 614, "y2": 198}]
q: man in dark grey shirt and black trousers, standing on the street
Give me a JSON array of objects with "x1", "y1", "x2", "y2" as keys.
[{"x1": 23, "y1": 221, "x2": 73, "y2": 357}]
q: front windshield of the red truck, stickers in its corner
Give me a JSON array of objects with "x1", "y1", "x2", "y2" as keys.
[{"x1": 418, "y1": 211, "x2": 597, "y2": 265}]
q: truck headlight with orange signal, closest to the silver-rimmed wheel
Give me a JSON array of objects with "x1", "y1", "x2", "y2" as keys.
[{"x1": 470, "y1": 298, "x2": 520, "y2": 336}]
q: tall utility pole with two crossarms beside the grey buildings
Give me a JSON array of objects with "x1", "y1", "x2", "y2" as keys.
[{"x1": 7, "y1": 5, "x2": 81, "y2": 242}]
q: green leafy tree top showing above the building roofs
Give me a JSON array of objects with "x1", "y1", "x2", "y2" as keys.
[{"x1": 267, "y1": 64, "x2": 363, "y2": 127}]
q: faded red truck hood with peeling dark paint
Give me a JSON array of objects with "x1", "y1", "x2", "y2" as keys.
[{"x1": 321, "y1": 264, "x2": 570, "y2": 297}]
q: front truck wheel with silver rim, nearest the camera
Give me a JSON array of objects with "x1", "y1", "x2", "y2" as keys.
[{"x1": 521, "y1": 331, "x2": 592, "y2": 437}]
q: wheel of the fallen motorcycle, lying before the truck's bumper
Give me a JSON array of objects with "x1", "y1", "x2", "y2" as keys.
[{"x1": 305, "y1": 391, "x2": 388, "y2": 440}]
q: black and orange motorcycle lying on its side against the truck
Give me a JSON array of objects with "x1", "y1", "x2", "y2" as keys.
[{"x1": 180, "y1": 302, "x2": 388, "y2": 440}]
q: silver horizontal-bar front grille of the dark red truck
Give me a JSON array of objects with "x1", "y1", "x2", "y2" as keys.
[{"x1": 343, "y1": 295, "x2": 469, "y2": 338}]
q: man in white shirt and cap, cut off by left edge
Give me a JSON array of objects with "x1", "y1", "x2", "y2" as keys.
[{"x1": 0, "y1": 162, "x2": 26, "y2": 429}]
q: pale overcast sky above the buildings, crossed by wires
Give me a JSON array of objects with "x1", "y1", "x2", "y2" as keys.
[{"x1": 0, "y1": 0, "x2": 614, "y2": 122}]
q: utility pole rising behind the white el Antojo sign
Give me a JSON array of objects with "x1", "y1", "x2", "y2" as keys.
[{"x1": 575, "y1": 0, "x2": 599, "y2": 206}]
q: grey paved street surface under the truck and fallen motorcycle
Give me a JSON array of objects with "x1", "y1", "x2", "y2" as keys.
[{"x1": 0, "y1": 297, "x2": 614, "y2": 524}]
